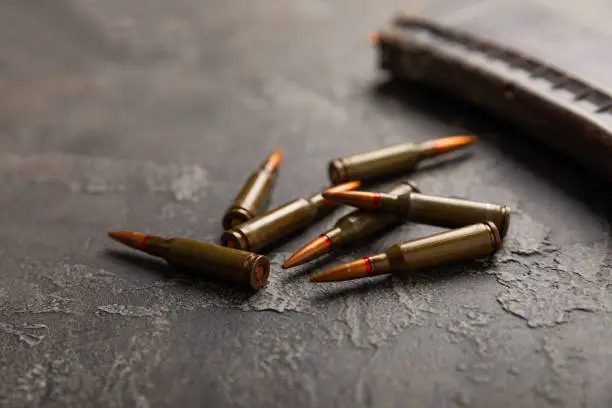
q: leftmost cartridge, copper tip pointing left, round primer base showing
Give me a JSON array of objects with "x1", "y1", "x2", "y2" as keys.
[{"x1": 108, "y1": 231, "x2": 270, "y2": 290}]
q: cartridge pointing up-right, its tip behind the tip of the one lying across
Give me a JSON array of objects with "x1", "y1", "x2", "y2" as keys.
[{"x1": 221, "y1": 181, "x2": 360, "y2": 252}]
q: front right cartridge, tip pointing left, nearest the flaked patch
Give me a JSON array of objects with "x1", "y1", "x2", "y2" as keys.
[{"x1": 311, "y1": 222, "x2": 501, "y2": 282}]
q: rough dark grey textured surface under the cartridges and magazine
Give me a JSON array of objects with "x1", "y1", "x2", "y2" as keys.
[{"x1": 0, "y1": 0, "x2": 612, "y2": 408}]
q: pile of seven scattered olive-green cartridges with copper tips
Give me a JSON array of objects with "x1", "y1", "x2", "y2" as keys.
[{"x1": 108, "y1": 136, "x2": 510, "y2": 290}]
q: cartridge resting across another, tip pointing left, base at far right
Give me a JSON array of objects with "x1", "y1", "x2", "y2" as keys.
[{"x1": 323, "y1": 191, "x2": 510, "y2": 237}]
